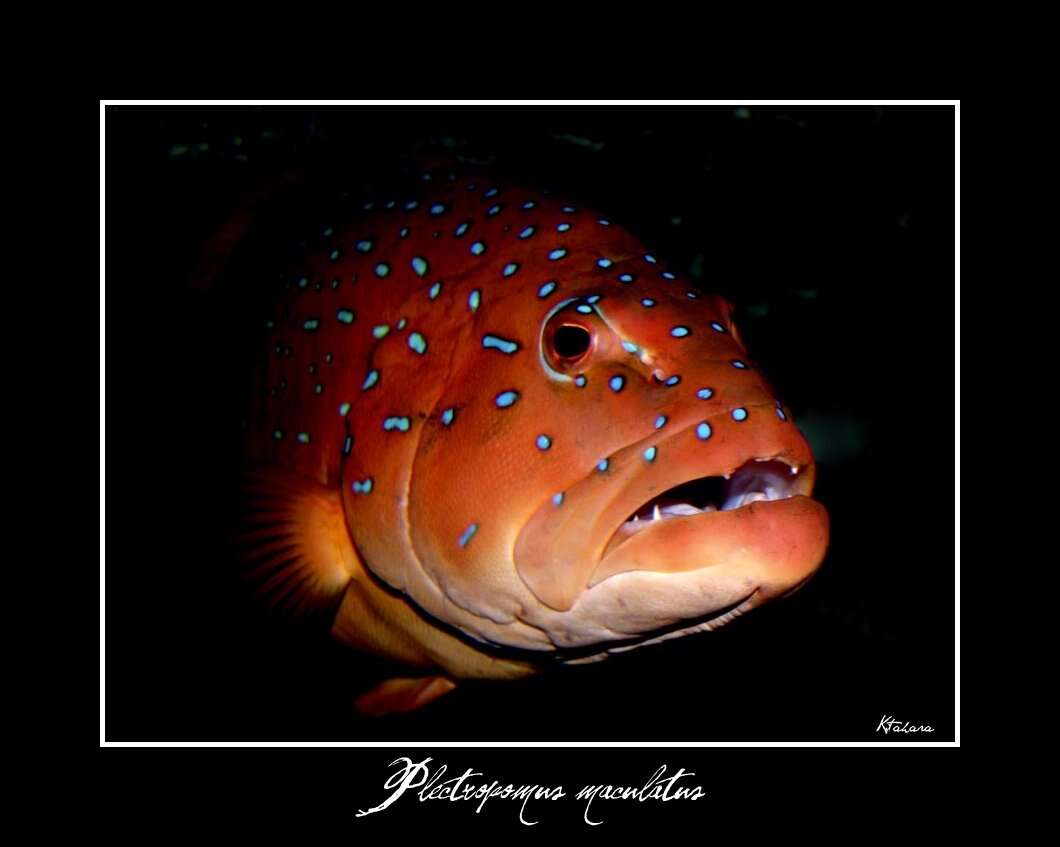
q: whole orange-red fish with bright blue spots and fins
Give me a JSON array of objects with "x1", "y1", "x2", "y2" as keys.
[{"x1": 240, "y1": 177, "x2": 829, "y2": 714}]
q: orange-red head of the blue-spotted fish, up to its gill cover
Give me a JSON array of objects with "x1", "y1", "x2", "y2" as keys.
[{"x1": 345, "y1": 199, "x2": 828, "y2": 654}]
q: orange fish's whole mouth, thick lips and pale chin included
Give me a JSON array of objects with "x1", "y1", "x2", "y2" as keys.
[{"x1": 514, "y1": 404, "x2": 828, "y2": 619}]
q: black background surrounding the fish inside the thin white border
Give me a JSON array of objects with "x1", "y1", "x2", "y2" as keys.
[{"x1": 106, "y1": 107, "x2": 955, "y2": 742}]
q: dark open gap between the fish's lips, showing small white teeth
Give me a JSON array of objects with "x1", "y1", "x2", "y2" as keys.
[{"x1": 604, "y1": 459, "x2": 803, "y2": 555}]
